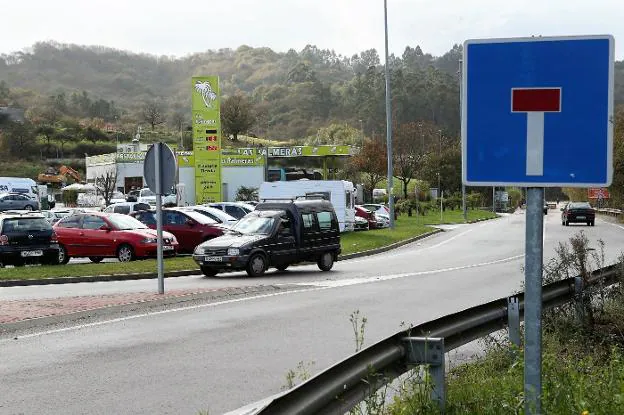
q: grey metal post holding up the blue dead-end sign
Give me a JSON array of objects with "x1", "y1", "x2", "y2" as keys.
[{"x1": 524, "y1": 187, "x2": 544, "y2": 414}]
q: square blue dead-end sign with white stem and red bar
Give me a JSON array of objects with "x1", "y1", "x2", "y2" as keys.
[{"x1": 462, "y1": 35, "x2": 614, "y2": 187}]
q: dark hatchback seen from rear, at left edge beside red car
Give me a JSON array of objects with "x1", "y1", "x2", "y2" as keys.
[{"x1": 0, "y1": 213, "x2": 59, "y2": 267}]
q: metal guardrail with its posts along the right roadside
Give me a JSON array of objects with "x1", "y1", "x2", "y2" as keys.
[{"x1": 228, "y1": 264, "x2": 620, "y2": 415}]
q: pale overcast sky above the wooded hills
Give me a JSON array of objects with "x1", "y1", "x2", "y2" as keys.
[{"x1": 0, "y1": 0, "x2": 624, "y2": 61}]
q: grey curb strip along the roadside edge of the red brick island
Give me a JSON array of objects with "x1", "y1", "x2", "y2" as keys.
[{"x1": 0, "y1": 285, "x2": 306, "y2": 335}]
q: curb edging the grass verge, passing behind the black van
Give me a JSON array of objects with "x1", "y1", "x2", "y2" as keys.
[{"x1": 0, "y1": 221, "x2": 498, "y2": 287}]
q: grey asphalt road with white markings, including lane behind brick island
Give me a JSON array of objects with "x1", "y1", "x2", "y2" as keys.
[{"x1": 0, "y1": 211, "x2": 624, "y2": 414}]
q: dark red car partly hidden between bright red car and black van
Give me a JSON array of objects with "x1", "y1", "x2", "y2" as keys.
[{"x1": 131, "y1": 208, "x2": 229, "y2": 253}]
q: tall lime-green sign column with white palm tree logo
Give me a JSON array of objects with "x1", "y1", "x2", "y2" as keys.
[{"x1": 192, "y1": 76, "x2": 221, "y2": 204}]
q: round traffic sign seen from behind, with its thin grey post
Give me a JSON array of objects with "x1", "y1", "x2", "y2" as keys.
[{"x1": 143, "y1": 143, "x2": 177, "y2": 294}]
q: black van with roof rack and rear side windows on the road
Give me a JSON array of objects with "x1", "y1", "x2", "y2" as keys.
[{"x1": 193, "y1": 200, "x2": 340, "y2": 277}]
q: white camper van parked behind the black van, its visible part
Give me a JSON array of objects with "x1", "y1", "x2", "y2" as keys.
[{"x1": 258, "y1": 179, "x2": 355, "y2": 232}]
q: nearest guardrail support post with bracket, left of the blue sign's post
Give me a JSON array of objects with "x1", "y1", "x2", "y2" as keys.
[{"x1": 403, "y1": 337, "x2": 446, "y2": 413}]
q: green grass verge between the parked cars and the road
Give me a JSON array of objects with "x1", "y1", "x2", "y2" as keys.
[{"x1": 0, "y1": 210, "x2": 494, "y2": 280}]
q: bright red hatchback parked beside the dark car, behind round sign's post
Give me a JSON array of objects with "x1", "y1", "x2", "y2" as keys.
[{"x1": 54, "y1": 212, "x2": 178, "y2": 264}]
